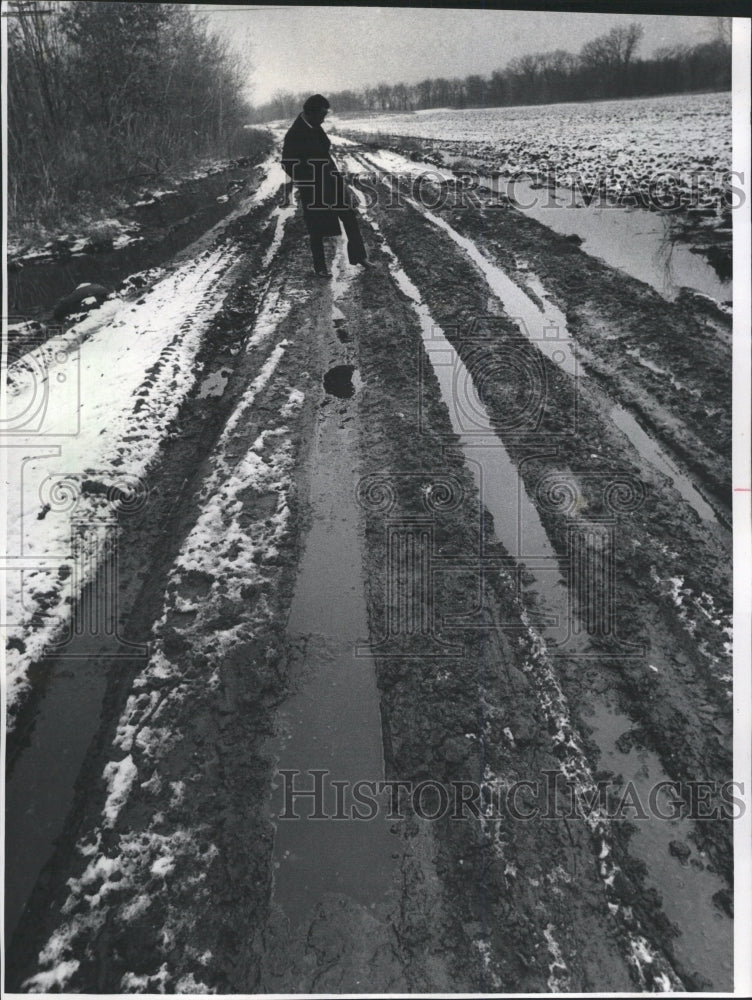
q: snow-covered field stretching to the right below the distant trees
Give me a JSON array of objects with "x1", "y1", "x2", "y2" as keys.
[{"x1": 331, "y1": 93, "x2": 731, "y2": 206}]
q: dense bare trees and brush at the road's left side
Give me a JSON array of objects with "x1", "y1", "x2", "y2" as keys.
[{"x1": 4, "y1": 0, "x2": 258, "y2": 227}]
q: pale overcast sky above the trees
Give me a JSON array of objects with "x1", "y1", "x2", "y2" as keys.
[{"x1": 195, "y1": 4, "x2": 714, "y2": 104}]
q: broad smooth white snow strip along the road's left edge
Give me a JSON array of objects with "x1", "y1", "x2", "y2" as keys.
[{"x1": 4, "y1": 163, "x2": 289, "y2": 724}]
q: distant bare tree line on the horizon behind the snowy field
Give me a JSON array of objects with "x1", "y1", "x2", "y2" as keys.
[{"x1": 253, "y1": 18, "x2": 731, "y2": 122}]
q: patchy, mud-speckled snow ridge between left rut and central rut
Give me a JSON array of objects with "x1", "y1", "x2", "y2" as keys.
[{"x1": 25, "y1": 296, "x2": 304, "y2": 993}]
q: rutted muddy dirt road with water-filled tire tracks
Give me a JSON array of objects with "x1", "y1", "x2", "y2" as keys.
[{"x1": 6, "y1": 131, "x2": 739, "y2": 993}]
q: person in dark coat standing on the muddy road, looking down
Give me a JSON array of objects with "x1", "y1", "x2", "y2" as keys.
[{"x1": 282, "y1": 94, "x2": 369, "y2": 278}]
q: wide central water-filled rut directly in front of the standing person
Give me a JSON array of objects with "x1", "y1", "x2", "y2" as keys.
[{"x1": 272, "y1": 256, "x2": 397, "y2": 929}]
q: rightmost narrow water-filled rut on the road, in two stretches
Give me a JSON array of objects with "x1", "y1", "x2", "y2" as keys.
[{"x1": 356, "y1": 148, "x2": 719, "y2": 524}]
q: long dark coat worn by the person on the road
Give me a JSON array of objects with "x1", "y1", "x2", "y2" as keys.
[{"x1": 282, "y1": 115, "x2": 352, "y2": 236}]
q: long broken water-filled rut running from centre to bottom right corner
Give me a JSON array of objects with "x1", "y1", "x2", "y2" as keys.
[{"x1": 362, "y1": 203, "x2": 733, "y2": 990}]
